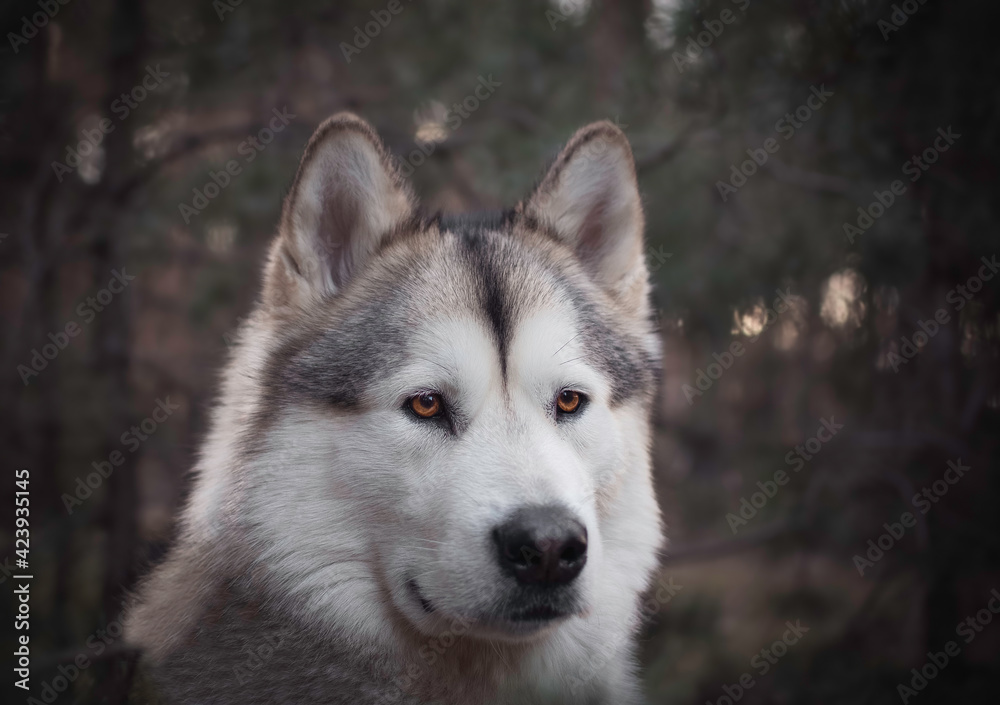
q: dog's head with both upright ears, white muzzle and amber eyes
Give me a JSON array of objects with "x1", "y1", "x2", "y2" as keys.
[{"x1": 243, "y1": 116, "x2": 657, "y2": 639}]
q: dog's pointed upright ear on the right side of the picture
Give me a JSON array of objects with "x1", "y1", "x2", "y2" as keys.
[{"x1": 521, "y1": 121, "x2": 647, "y2": 297}]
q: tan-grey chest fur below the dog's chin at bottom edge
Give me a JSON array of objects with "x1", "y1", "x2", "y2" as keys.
[{"x1": 143, "y1": 580, "x2": 633, "y2": 705}]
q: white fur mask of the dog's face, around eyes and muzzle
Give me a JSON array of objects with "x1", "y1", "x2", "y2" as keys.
[{"x1": 226, "y1": 294, "x2": 661, "y2": 703}]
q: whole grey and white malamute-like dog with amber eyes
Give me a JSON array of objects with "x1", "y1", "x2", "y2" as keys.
[{"x1": 126, "y1": 114, "x2": 663, "y2": 705}]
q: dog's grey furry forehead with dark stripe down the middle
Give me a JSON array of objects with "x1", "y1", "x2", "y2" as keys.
[{"x1": 282, "y1": 217, "x2": 649, "y2": 408}]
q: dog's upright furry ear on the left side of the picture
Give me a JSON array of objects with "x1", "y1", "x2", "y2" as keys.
[{"x1": 264, "y1": 113, "x2": 415, "y2": 308}]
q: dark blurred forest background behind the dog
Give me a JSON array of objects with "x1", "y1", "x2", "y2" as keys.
[{"x1": 0, "y1": 0, "x2": 1000, "y2": 705}]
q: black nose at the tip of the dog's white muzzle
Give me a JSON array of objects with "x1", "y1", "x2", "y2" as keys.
[{"x1": 493, "y1": 506, "x2": 587, "y2": 587}]
